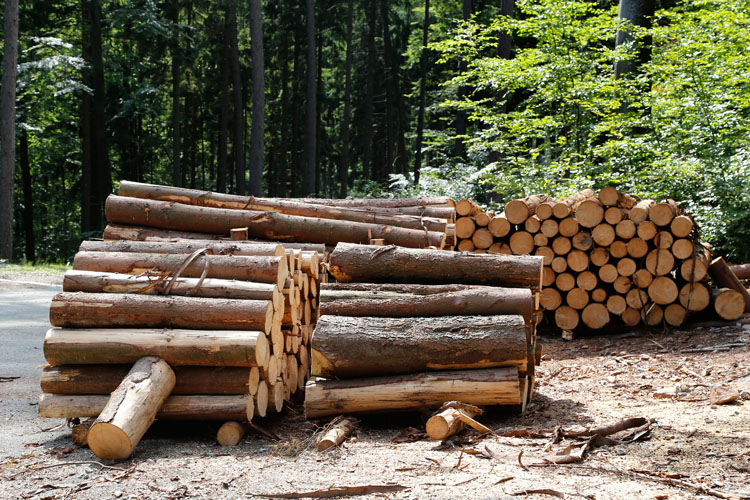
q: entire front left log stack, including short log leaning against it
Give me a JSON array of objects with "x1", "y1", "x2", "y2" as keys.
[{"x1": 39, "y1": 239, "x2": 325, "y2": 458}]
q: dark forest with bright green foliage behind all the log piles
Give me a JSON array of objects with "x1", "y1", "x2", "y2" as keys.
[{"x1": 0, "y1": 0, "x2": 750, "y2": 262}]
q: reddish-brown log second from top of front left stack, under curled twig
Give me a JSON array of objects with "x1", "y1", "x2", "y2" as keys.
[{"x1": 73, "y1": 252, "x2": 289, "y2": 288}]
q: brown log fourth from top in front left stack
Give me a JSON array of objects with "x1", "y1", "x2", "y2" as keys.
[{"x1": 49, "y1": 292, "x2": 273, "y2": 333}]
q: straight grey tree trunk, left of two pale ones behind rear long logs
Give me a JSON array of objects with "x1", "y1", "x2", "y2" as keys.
[{"x1": 249, "y1": 0, "x2": 266, "y2": 196}]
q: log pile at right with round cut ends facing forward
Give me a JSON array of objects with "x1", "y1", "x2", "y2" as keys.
[{"x1": 455, "y1": 187, "x2": 750, "y2": 330}]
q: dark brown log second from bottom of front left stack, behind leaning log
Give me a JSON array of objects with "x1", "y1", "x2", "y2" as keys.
[{"x1": 40, "y1": 364, "x2": 259, "y2": 394}]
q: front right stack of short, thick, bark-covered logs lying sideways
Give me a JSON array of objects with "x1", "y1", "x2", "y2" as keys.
[{"x1": 305, "y1": 243, "x2": 542, "y2": 418}]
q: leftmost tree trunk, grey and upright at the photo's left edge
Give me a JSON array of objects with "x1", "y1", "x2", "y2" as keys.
[{"x1": 0, "y1": 0, "x2": 18, "y2": 260}]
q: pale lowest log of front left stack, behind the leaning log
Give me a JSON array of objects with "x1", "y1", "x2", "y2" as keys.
[{"x1": 38, "y1": 394, "x2": 255, "y2": 420}]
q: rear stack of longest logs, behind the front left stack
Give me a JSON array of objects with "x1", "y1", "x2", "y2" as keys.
[{"x1": 104, "y1": 181, "x2": 455, "y2": 249}]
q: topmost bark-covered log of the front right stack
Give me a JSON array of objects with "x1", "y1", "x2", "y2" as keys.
[{"x1": 329, "y1": 243, "x2": 543, "y2": 290}]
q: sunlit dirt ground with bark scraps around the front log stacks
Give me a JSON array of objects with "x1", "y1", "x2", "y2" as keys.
[{"x1": 0, "y1": 278, "x2": 750, "y2": 499}]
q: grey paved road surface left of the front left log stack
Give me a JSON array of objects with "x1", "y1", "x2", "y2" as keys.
[{"x1": 0, "y1": 280, "x2": 70, "y2": 460}]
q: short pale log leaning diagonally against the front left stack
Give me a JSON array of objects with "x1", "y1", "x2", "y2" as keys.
[{"x1": 88, "y1": 356, "x2": 175, "y2": 460}]
